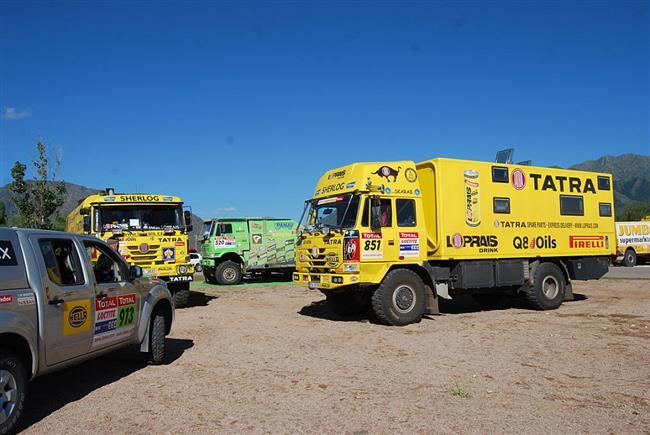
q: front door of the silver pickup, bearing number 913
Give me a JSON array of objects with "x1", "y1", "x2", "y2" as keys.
[{"x1": 83, "y1": 240, "x2": 143, "y2": 349}]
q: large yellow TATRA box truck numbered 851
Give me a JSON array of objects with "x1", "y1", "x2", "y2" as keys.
[{"x1": 293, "y1": 158, "x2": 616, "y2": 325}]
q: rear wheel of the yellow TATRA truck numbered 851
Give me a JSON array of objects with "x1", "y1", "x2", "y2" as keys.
[{"x1": 526, "y1": 263, "x2": 566, "y2": 310}]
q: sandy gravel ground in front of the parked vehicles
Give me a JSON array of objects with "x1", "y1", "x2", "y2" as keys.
[{"x1": 17, "y1": 279, "x2": 650, "y2": 434}]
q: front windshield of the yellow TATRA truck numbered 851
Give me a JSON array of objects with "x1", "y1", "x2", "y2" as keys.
[{"x1": 305, "y1": 193, "x2": 359, "y2": 231}]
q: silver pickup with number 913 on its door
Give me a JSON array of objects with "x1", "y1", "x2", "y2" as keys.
[{"x1": 0, "y1": 228, "x2": 174, "y2": 433}]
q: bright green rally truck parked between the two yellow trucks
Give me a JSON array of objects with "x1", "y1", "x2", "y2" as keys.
[{"x1": 201, "y1": 218, "x2": 298, "y2": 285}]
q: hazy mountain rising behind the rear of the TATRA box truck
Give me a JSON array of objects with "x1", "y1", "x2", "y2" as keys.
[{"x1": 569, "y1": 154, "x2": 650, "y2": 208}]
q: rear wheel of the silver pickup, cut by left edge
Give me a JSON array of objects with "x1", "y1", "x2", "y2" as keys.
[{"x1": 0, "y1": 349, "x2": 27, "y2": 435}]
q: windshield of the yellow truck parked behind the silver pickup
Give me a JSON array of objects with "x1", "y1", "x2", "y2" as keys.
[{"x1": 99, "y1": 205, "x2": 183, "y2": 231}]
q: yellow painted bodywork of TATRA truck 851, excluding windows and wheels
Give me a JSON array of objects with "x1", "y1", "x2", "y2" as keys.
[{"x1": 295, "y1": 158, "x2": 616, "y2": 288}]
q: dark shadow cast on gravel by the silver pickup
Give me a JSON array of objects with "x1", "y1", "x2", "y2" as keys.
[{"x1": 17, "y1": 338, "x2": 194, "y2": 432}]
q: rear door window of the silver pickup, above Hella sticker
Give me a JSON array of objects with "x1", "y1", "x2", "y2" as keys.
[{"x1": 38, "y1": 239, "x2": 84, "y2": 286}]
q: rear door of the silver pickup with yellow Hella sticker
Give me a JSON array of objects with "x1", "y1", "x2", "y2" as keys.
[{"x1": 30, "y1": 236, "x2": 95, "y2": 365}]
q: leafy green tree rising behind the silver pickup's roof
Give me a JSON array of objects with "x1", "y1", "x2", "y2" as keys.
[{"x1": 9, "y1": 142, "x2": 65, "y2": 230}]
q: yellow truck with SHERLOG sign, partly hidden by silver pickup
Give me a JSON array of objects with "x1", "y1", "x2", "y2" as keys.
[{"x1": 66, "y1": 188, "x2": 194, "y2": 307}]
